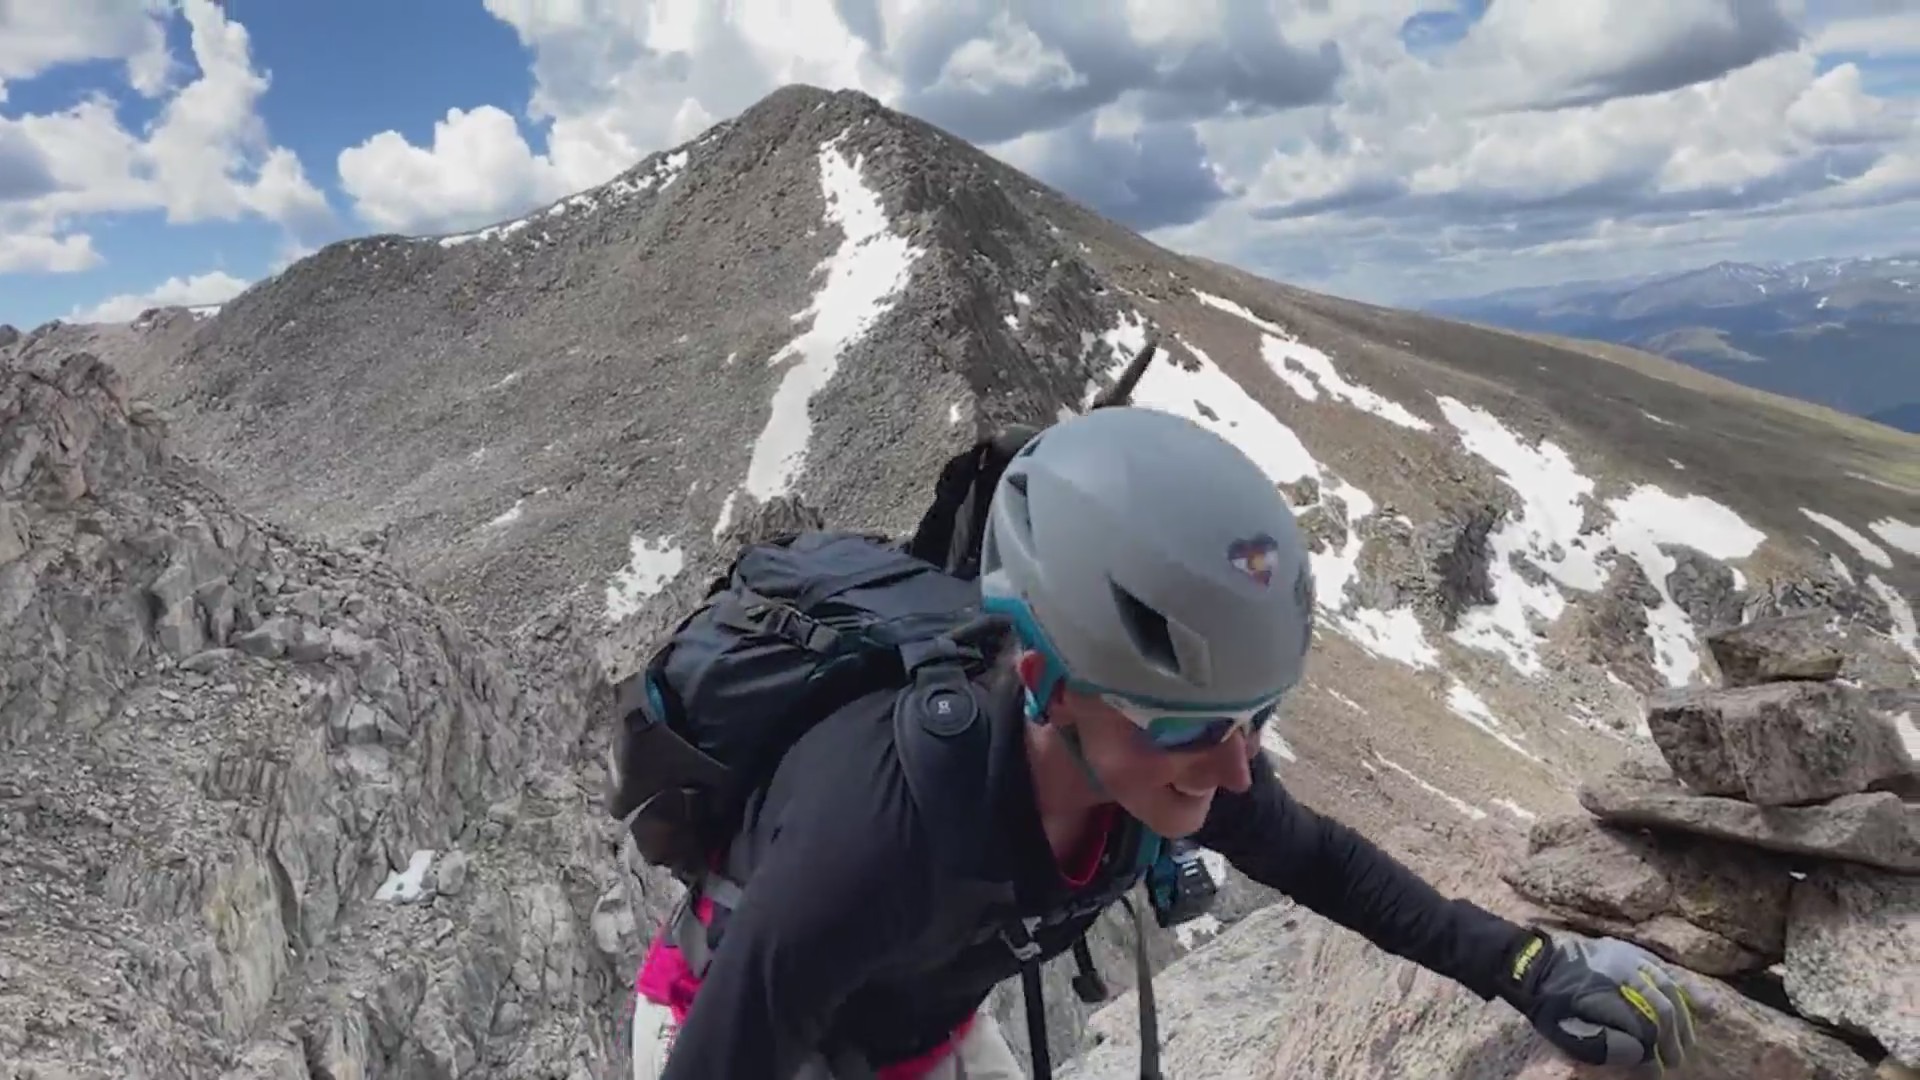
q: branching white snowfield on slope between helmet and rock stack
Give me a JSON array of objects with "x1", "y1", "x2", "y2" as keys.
[{"x1": 1436, "y1": 396, "x2": 1766, "y2": 686}]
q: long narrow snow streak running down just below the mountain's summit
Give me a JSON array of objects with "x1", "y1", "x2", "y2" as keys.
[{"x1": 747, "y1": 133, "x2": 922, "y2": 502}]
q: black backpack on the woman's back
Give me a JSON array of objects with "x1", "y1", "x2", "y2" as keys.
[{"x1": 607, "y1": 530, "x2": 996, "y2": 882}]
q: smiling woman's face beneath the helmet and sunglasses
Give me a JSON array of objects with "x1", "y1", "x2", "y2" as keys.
[{"x1": 1021, "y1": 653, "x2": 1260, "y2": 840}]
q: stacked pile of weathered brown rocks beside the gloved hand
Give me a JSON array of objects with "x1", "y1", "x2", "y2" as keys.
[{"x1": 1505, "y1": 613, "x2": 1920, "y2": 1067}]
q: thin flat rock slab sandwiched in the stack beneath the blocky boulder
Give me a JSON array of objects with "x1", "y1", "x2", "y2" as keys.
[{"x1": 1578, "y1": 771, "x2": 1920, "y2": 874}]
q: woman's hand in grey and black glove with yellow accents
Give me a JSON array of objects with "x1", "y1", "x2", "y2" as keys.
[{"x1": 1500, "y1": 930, "x2": 1693, "y2": 1070}]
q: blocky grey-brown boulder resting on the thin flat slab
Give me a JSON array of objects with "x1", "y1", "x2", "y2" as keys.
[{"x1": 1647, "y1": 682, "x2": 1914, "y2": 805}]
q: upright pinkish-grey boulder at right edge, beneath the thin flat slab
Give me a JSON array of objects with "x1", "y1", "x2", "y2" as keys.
[{"x1": 1784, "y1": 865, "x2": 1920, "y2": 1067}]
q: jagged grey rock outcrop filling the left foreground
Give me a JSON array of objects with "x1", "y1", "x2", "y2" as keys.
[{"x1": 0, "y1": 352, "x2": 628, "y2": 1080}]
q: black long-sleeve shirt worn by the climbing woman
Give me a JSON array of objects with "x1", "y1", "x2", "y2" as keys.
[{"x1": 662, "y1": 680, "x2": 1521, "y2": 1080}]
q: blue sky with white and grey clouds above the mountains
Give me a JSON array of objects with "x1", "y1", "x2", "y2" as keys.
[{"x1": 0, "y1": 0, "x2": 1920, "y2": 327}]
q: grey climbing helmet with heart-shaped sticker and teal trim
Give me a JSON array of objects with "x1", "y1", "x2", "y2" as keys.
[{"x1": 981, "y1": 407, "x2": 1313, "y2": 746}]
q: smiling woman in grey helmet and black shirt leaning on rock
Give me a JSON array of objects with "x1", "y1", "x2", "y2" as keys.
[{"x1": 634, "y1": 407, "x2": 1693, "y2": 1080}]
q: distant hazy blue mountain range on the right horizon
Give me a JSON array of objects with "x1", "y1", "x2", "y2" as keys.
[{"x1": 1427, "y1": 254, "x2": 1920, "y2": 432}]
